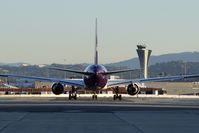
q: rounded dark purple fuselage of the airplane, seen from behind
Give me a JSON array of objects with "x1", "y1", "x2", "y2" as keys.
[{"x1": 83, "y1": 65, "x2": 108, "y2": 90}]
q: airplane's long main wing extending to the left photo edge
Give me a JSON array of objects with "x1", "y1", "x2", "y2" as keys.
[{"x1": 0, "y1": 74, "x2": 85, "y2": 87}]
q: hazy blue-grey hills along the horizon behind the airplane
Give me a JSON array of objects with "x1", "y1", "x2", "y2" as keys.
[{"x1": 0, "y1": 52, "x2": 199, "y2": 81}]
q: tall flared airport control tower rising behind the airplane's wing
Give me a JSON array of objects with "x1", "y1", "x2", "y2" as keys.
[{"x1": 137, "y1": 45, "x2": 152, "y2": 78}]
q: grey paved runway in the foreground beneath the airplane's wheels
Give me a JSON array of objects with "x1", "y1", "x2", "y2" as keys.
[{"x1": 0, "y1": 97, "x2": 199, "y2": 133}]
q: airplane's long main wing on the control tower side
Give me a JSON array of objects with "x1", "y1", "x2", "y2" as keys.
[{"x1": 107, "y1": 74, "x2": 199, "y2": 87}]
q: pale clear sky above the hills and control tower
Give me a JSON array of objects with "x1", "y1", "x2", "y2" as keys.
[{"x1": 0, "y1": 0, "x2": 199, "y2": 64}]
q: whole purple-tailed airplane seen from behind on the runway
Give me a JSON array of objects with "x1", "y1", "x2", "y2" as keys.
[{"x1": 0, "y1": 19, "x2": 199, "y2": 100}]
